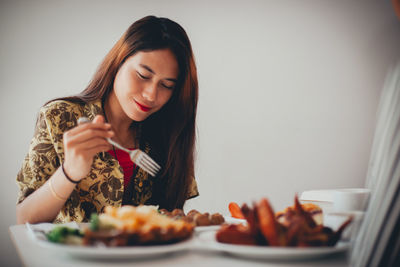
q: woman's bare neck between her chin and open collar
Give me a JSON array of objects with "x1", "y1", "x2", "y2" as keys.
[{"x1": 103, "y1": 91, "x2": 135, "y2": 148}]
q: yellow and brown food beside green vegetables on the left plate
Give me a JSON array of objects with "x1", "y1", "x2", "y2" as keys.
[{"x1": 83, "y1": 205, "x2": 194, "y2": 246}]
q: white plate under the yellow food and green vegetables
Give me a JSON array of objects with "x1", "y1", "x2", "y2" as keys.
[{"x1": 37, "y1": 239, "x2": 192, "y2": 259}]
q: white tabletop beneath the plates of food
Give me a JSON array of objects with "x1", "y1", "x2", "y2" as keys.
[{"x1": 9, "y1": 225, "x2": 349, "y2": 267}]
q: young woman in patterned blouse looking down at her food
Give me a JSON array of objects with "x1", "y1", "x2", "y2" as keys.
[{"x1": 17, "y1": 16, "x2": 198, "y2": 223}]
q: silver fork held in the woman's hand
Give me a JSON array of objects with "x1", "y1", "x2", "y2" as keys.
[{"x1": 78, "y1": 117, "x2": 161, "y2": 177}]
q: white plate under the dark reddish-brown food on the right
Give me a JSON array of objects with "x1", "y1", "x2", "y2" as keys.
[{"x1": 198, "y1": 232, "x2": 350, "y2": 261}]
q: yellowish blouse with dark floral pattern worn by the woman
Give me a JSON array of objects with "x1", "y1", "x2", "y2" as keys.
[{"x1": 17, "y1": 100, "x2": 198, "y2": 223}]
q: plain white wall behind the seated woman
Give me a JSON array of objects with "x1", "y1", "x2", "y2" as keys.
[{"x1": 0, "y1": 0, "x2": 400, "y2": 266}]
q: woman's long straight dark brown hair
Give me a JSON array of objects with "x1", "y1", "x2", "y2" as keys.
[{"x1": 54, "y1": 16, "x2": 198, "y2": 209}]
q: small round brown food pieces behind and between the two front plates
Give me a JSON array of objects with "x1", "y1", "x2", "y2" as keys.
[{"x1": 160, "y1": 209, "x2": 225, "y2": 226}]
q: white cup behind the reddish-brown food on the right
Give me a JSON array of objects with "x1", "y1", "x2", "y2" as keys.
[{"x1": 333, "y1": 188, "x2": 371, "y2": 212}]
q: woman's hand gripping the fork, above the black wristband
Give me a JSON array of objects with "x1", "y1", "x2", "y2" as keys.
[{"x1": 64, "y1": 115, "x2": 114, "y2": 181}]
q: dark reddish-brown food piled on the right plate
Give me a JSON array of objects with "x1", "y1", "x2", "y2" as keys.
[{"x1": 216, "y1": 196, "x2": 352, "y2": 247}]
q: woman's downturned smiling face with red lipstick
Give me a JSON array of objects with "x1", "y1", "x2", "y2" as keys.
[{"x1": 113, "y1": 49, "x2": 179, "y2": 121}]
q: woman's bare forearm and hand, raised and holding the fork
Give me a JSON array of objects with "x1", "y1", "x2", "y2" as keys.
[{"x1": 17, "y1": 116, "x2": 114, "y2": 224}]
